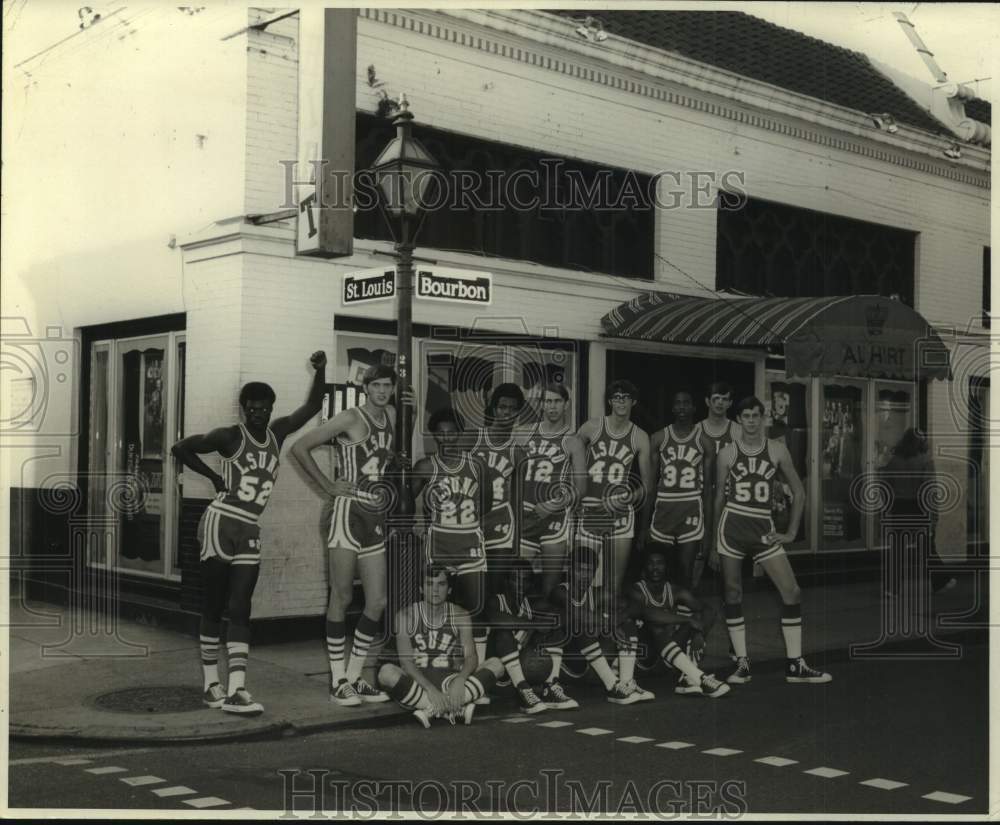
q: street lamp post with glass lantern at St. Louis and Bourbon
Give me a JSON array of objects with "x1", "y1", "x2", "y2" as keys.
[{"x1": 372, "y1": 95, "x2": 440, "y2": 515}]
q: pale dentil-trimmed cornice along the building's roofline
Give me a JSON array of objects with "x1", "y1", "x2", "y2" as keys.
[{"x1": 359, "y1": 8, "x2": 990, "y2": 189}]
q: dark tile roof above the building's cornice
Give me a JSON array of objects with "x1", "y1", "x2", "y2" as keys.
[{"x1": 551, "y1": 9, "x2": 952, "y2": 134}]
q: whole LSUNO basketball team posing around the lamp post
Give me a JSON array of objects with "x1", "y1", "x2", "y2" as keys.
[{"x1": 172, "y1": 352, "x2": 831, "y2": 727}]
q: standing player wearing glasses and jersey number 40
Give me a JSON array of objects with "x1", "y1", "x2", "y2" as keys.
[{"x1": 577, "y1": 381, "x2": 653, "y2": 600}]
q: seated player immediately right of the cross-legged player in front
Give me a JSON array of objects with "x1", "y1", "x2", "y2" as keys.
[{"x1": 487, "y1": 559, "x2": 579, "y2": 714}]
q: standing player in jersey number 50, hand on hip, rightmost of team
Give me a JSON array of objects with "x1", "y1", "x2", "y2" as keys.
[{"x1": 709, "y1": 396, "x2": 832, "y2": 684}]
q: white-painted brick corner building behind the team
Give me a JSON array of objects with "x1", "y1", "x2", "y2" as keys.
[{"x1": 5, "y1": 9, "x2": 990, "y2": 619}]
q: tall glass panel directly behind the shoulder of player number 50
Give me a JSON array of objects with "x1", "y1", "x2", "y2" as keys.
[{"x1": 764, "y1": 373, "x2": 811, "y2": 544}]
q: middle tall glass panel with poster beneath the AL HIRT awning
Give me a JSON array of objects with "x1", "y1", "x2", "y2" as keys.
[{"x1": 820, "y1": 384, "x2": 865, "y2": 550}]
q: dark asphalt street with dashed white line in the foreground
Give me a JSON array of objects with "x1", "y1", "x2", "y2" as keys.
[{"x1": 9, "y1": 642, "x2": 988, "y2": 816}]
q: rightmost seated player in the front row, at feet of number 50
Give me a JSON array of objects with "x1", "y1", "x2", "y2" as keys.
[{"x1": 628, "y1": 547, "x2": 729, "y2": 699}]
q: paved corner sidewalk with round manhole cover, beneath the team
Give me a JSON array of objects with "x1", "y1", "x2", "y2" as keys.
[{"x1": 9, "y1": 576, "x2": 985, "y2": 742}]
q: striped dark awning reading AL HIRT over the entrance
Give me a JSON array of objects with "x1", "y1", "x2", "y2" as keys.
[{"x1": 601, "y1": 292, "x2": 950, "y2": 380}]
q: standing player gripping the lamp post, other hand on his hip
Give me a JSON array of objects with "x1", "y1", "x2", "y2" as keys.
[{"x1": 292, "y1": 364, "x2": 412, "y2": 707}]
